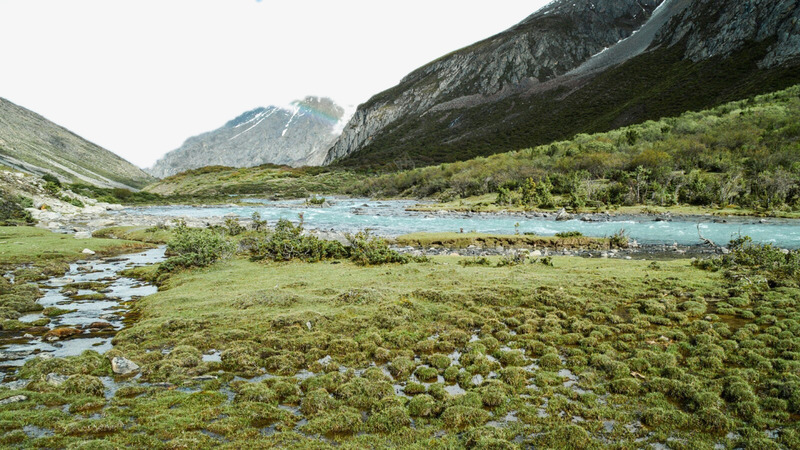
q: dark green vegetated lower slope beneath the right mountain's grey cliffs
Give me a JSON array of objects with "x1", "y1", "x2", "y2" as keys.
[{"x1": 335, "y1": 39, "x2": 800, "y2": 170}]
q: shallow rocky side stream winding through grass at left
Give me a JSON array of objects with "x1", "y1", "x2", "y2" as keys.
[{"x1": 0, "y1": 247, "x2": 166, "y2": 379}]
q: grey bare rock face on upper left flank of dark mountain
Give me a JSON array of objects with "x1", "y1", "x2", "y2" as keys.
[{"x1": 325, "y1": 0, "x2": 662, "y2": 164}]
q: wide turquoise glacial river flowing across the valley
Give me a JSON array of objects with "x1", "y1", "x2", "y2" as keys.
[{"x1": 123, "y1": 198, "x2": 800, "y2": 248}]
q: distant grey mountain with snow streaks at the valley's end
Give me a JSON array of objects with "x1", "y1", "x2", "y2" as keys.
[{"x1": 148, "y1": 97, "x2": 344, "y2": 178}]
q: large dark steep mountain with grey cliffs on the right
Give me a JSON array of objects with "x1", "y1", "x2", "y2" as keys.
[{"x1": 325, "y1": 0, "x2": 800, "y2": 169}]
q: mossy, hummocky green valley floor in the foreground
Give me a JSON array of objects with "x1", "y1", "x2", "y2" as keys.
[{"x1": 0, "y1": 227, "x2": 800, "y2": 449}]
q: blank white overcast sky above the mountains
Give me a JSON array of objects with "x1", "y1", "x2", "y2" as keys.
[{"x1": 0, "y1": 0, "x2": 548, "y2": 167}]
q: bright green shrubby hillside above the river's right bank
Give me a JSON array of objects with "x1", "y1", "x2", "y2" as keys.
[{"x1": 351, "y1": 86, "x2": 800, "y2": 216}]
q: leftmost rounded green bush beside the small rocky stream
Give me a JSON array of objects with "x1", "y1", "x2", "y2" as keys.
[{"x1": 159, "y1": 224, "x2": 236, "y2": 273}]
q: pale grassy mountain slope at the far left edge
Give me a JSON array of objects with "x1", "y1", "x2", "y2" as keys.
[{"x1": 0, "y1": 98, "x2": 153, "y2": 190}]
